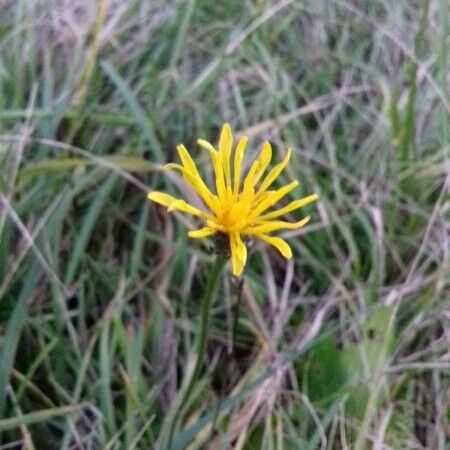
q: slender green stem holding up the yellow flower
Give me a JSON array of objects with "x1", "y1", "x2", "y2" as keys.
[{"x1": 166, "y1": 255, "x2": 226, "y2": 450}]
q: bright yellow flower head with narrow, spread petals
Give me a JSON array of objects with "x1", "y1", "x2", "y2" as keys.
[{"x1": 148, "y1": 123, "x2": 318, "y2": 276}]
